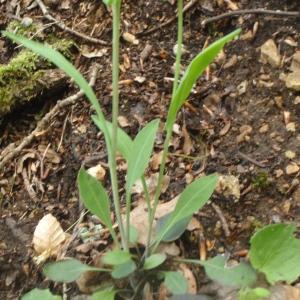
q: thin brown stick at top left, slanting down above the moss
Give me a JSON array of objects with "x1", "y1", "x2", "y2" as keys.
[{"x1": 35, "y1": 0, "x2": 109, "y2": 46}]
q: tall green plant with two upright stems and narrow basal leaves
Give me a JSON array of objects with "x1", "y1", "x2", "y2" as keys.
[{"x1": 4, "y1": 0, "x2": 240, "y2": 299}]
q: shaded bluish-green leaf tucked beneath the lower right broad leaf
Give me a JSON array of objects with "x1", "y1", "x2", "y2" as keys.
[{"x1": 156, "y1": 213, "x2": 193, "y2": 242}]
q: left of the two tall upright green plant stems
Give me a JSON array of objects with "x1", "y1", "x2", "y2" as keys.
[{"x1": 109, "y1": 1, "x2": 128, "y2": 250}]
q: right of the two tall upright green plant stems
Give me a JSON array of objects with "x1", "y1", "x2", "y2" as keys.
[{"x1": 145, "y1": 0, "x2": 183, "y2": 257}]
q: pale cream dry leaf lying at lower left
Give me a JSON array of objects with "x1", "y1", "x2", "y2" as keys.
[{"x1": 32, "y1": 214, "x2": 66, "y2": 263}]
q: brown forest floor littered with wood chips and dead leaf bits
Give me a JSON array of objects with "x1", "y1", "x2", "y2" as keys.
[{"x1": 0, "y1": 0, "x2": 300, "y2": 299}]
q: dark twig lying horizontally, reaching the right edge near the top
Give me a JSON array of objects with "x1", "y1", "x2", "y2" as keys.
[{"x1": 201, "y1": 8, "x2": 300, "y2": 26}]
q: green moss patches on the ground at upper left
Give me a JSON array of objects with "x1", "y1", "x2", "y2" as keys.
[{"x1": 0, "y1": 21, "x2": 74, "y2": 118}]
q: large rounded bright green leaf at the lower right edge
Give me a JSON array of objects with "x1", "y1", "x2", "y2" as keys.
[{"x1": 250, "y1": 224, "x2": 300, "y2": 284}]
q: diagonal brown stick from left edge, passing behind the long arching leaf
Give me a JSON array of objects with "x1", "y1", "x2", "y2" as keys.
[{"x1": 0, "y1": 64, "x2": 100, "y2": 170}]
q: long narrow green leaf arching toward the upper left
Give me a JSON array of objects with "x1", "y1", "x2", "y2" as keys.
[{"x1": 2, "y1": 31, "x2": 106, "y2": 130}]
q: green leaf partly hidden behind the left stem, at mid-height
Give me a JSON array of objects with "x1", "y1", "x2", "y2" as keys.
[{"x1": 92, "y1": 116, "x2": 133, "y2": 161}]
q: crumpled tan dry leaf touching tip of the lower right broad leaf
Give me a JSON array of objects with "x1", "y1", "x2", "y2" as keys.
[{"x1": 216, "y1": 175, "x2": 241, "y2": 200}]
